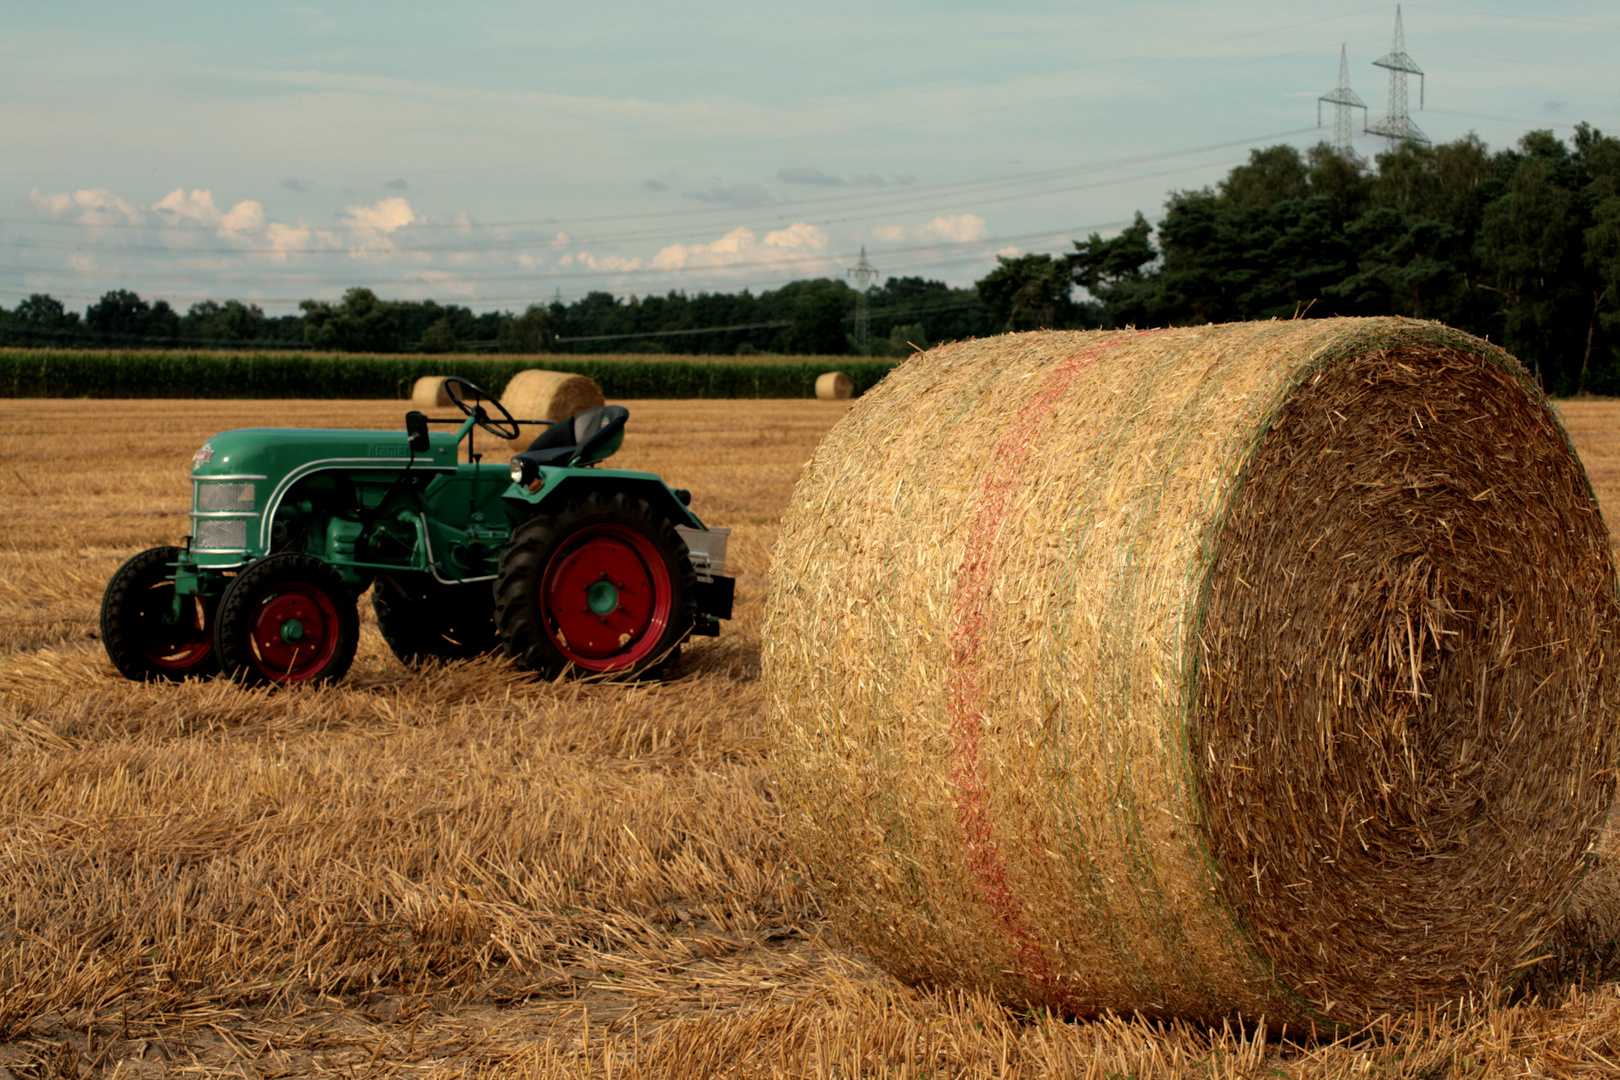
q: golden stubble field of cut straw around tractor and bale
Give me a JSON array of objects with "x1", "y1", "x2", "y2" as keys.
[{"x1": 0, "y1": 400, "x2": 1620, "y2": 1080}]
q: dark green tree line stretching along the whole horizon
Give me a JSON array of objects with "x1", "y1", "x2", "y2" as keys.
[{"x1": 0, "y1": 125, "x2": 1620, "y2": 393}]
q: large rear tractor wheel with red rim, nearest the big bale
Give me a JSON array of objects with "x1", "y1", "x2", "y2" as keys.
[{"x1": 496, "y1": 492, "x2": 697, "y2": 678}]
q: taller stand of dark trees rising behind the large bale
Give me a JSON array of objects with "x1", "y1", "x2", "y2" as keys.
[{"x1": 1056, "y1": 125, "x2": 1620, "y2": 393}]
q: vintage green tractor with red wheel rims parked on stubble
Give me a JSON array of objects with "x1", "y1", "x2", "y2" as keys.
[{"x1": 100, "y1": 379, "x2": 734, "y2": 683}]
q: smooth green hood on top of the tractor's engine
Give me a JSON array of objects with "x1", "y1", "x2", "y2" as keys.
[{"x1": 191, "y1": 427, "x2": 469, "y2": 479}]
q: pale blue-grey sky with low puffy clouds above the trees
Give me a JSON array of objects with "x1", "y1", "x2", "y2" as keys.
[{"x1": 0, "y1": 0, "x2": 1620, "y2": 314}]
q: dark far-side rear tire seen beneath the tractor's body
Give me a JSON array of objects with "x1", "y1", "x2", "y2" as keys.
[{"x1": 371, "y1": 573, "x2": 501, "y2": 664}]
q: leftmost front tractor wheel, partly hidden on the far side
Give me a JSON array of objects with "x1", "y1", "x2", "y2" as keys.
[{"x1": 100, "y1": 547, "x2": 219, "y2": 682}]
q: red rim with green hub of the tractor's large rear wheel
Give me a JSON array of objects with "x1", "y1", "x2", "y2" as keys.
[{"x1": 539, "y1": 525, "x2": 672, "y2": 672}]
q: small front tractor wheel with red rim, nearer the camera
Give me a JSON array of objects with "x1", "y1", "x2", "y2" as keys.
[{"x1": 214, "y1": 552, "x2": 360, "y2": 685}]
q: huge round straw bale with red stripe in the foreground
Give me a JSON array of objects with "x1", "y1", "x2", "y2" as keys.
[{"x1": 763, "y1": 319, "x2": 1620, "y2": 1023}]
